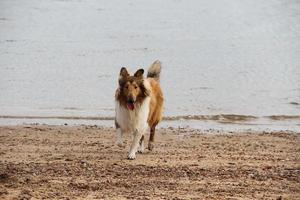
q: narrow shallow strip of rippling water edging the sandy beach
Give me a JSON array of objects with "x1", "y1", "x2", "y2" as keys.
[{"x1": 0, "y1": 114, "x2": 300, "y2": 133}]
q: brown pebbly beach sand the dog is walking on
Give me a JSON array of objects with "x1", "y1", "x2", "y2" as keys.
[{"x1": 0, "y1": 125, "x2": 300, "y2": 199}]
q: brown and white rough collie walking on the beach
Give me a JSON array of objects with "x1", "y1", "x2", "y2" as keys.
[{"x1": 115, "y1": 61, "x2": 164, "y2": 159}]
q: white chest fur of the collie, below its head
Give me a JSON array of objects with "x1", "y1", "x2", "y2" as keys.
[{"x1": 116, "y1": 97, "x2": 150, "y2": 132}]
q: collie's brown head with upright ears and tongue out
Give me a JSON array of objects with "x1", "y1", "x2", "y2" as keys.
[{"x1": 119, "y1": 67, "x2": 149, "y2": 110}]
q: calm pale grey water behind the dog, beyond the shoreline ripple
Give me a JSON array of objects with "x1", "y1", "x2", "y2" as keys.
[{"x1": 0, "y1": 0, "x2": 300, "y2": 130}]
